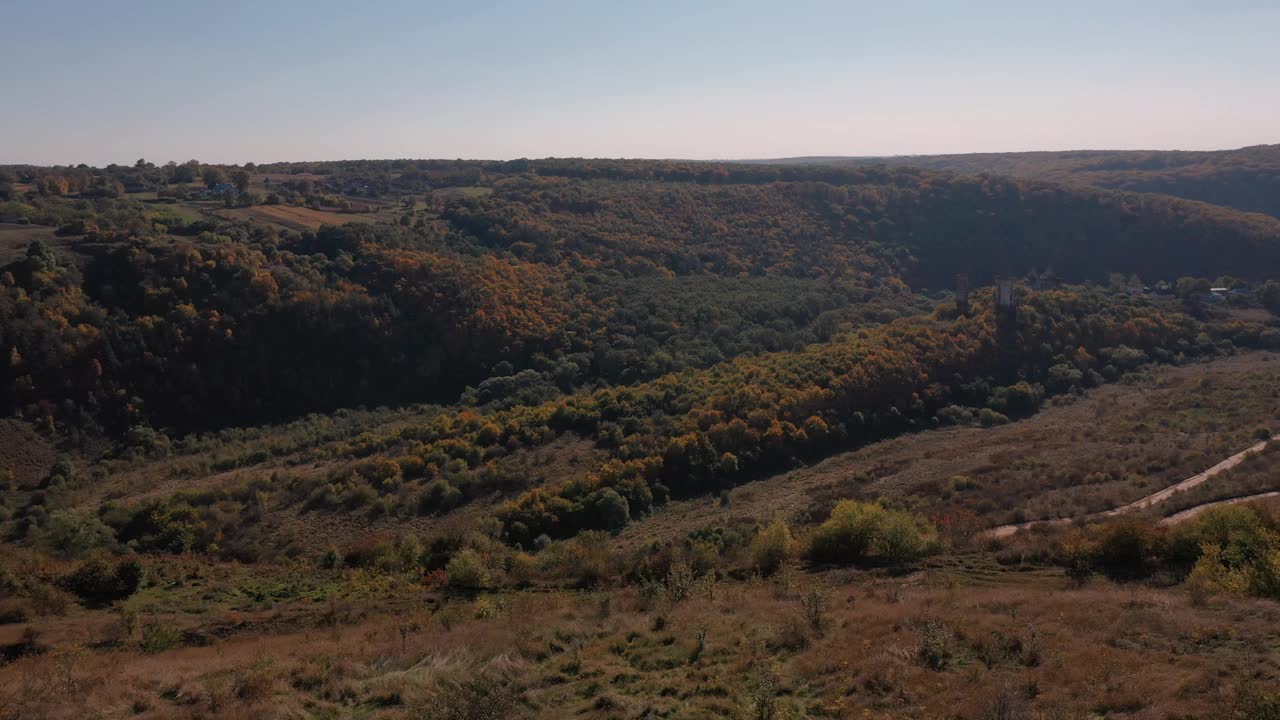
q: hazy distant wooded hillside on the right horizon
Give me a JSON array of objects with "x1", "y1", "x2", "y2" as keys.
[{"x1": 751, "y1": 145, "x2": 1280, "y2": 217}]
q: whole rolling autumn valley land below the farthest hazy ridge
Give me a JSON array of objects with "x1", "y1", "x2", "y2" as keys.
[{"x1": 0, "y1": 159, "x2": 1280, "y2": 720}]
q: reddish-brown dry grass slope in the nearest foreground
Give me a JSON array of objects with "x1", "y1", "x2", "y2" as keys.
[{"x1": 0, "y1": 557, "x2": 1280, "y2": 720}]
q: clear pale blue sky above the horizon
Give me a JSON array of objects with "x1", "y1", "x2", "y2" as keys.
[{"x1": 0, "y1": 0, "x2": 1280, "y2": 164}]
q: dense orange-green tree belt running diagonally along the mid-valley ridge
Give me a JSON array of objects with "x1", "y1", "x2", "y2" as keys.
[{"x1": 493, "y1": 283, "x2": 1228, "y2": 542}]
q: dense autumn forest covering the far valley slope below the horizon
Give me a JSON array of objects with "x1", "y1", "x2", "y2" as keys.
[{"x1": 0, "y1": 160, "x2": 1280, "y2": 433}]
